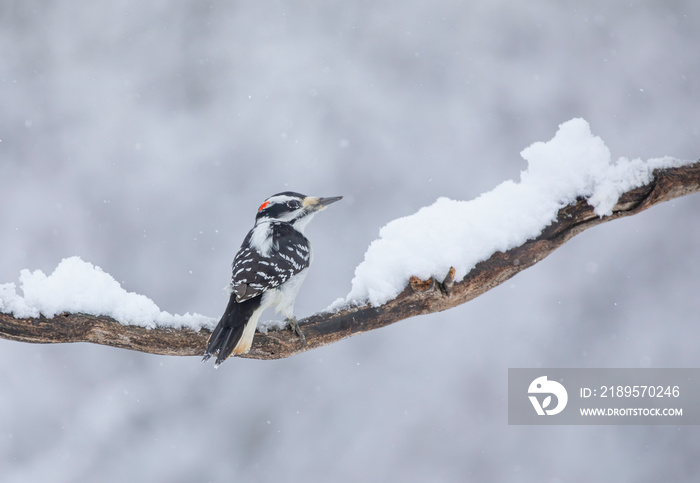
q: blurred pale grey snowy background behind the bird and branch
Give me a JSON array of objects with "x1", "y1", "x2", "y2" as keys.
[{"x1": 0, "y1": 0, "x2": 700, "y2": 483}]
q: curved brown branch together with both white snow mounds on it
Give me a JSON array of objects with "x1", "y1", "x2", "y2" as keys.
[{"x1": 0, "y1": 119, "x2": 700, "y2": 359}]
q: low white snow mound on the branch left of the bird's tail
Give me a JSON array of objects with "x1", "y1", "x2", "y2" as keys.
[{"x1": 0, "y1": 257, "x2": 215, "y2": 330}]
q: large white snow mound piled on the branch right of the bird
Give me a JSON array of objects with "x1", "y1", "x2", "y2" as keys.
[{"x1": 336, "y1": 119, "x2": 686, "y2": 310}]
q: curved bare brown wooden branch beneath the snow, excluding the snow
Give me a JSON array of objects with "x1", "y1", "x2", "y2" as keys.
[{"x1": 0, "y1": 161, "x2": 700, "y2": 359}]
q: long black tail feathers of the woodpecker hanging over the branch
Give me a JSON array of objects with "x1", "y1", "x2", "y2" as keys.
[{"x1": 202, "y1": 293, "x2": 262, "y2": 366}]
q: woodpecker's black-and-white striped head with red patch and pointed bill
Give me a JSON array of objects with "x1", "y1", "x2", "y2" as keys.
[{"x1": 255, "y1": 191, "x2": 343, "y2": 232}]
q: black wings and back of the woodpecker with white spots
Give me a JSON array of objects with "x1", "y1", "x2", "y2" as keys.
[{"x1": 231, "y1": 223, "x2": 311, "y2": 303}]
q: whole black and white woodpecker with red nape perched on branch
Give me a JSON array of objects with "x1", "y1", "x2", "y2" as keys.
[{"x1": 202, "y1": 191, "x2": 342, "y2": 366}]
